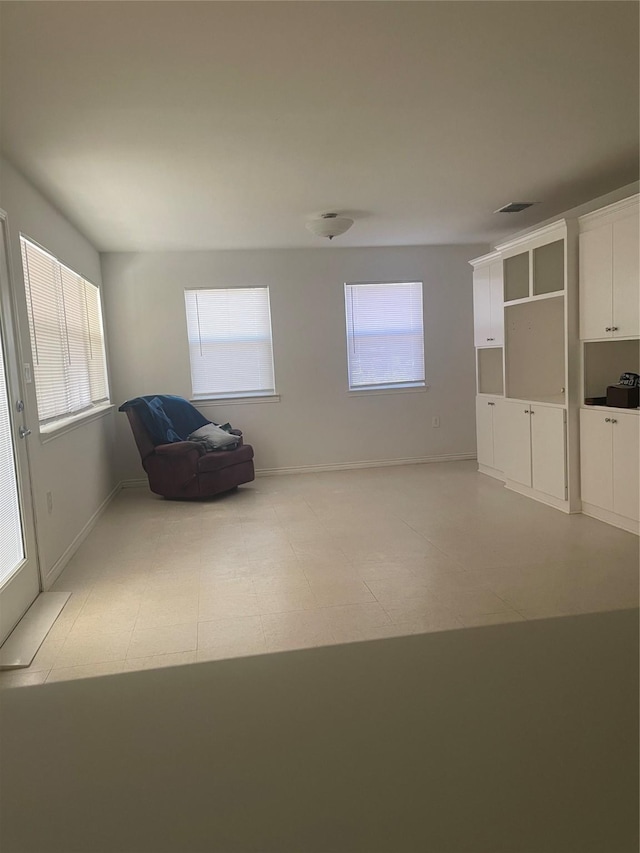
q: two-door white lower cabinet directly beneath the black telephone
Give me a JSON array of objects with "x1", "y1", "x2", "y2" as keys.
[{"x1": 580, "y1": 409, "x2": 640, "y2": 521}]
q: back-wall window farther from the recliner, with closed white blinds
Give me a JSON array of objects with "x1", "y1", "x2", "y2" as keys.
[{"x1": 344, "y1": 281, "x2": 425, "y2": 391}]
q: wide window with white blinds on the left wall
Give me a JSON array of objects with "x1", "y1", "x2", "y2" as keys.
[{"x1": 20, "y1": 237, "x2": 109, "y2": 424}]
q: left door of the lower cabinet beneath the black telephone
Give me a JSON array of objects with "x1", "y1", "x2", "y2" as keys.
[{"x1": 580, "y1": 409, "x2": 613, "y2": 511}]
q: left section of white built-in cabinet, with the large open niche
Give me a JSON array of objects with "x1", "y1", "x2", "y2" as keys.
[{"x1": 471, "y1": 220, "x2": 579, "y2": 512}]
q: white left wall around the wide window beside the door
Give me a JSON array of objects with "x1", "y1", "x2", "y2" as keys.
[{"x1": 0, "y1": 161, "x2": 117, "y2": 586}]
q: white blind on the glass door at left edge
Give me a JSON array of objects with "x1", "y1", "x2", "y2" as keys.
[{"x1": 0, "y1": 327, "x2": 24, "y2": 584}]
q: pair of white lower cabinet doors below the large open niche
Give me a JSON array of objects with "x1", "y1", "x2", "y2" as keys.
[{"x1": 502, "y1": 400, "x2": 567, "y2": 500}]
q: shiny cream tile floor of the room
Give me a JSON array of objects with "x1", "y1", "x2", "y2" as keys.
[{"x1": 0, "y1": 462, "x2": 638, "y2": 687}]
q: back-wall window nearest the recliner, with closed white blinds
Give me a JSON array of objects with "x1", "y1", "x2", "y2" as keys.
[{"x1": 184, "y1": 287, "x2": 275, "y2": 398}]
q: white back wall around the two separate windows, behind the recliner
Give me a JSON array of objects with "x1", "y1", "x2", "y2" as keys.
[{"x1": 102, "y1": 245, "x2": 486, "y2": 479}]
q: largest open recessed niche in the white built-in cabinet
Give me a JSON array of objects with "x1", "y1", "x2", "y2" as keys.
[{"x1": 504, "y1": 296, "x2": 566, "y2": 403}]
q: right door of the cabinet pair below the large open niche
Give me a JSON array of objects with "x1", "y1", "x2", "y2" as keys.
[{"x1": 531, "y1": 403, "x2": 567, "y2": 500}]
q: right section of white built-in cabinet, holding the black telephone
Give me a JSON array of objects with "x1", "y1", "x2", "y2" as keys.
[{"x1": 578, "y1": 195, "x2": 640, "y2": 533}]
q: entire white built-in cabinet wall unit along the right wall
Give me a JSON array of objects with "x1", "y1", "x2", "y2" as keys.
[{"x1": 470, "y1": 195, "x2": 640, "y2": 532}]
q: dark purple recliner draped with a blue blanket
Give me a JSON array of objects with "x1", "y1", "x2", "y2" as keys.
[{"x1": 125, "y1": 407, "x2": 255, "y2": 499}]
